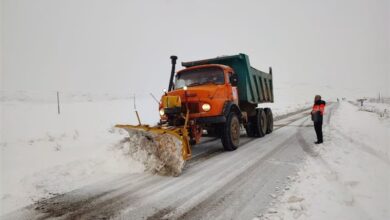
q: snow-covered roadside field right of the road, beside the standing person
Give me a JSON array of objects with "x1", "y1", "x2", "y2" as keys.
[{"x1": 258, "y1": 102, "x2": 390, "y2": 220}]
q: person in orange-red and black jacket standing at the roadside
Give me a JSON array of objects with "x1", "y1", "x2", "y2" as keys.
[{"x1": 311, "y1": 95, "x2": 326, "y2": 144}]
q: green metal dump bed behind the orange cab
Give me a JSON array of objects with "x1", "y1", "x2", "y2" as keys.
[{"x1": 182, "y1": 53, "x2": 274, "y2": 104}]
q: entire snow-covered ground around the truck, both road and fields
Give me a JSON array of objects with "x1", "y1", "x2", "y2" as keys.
[{"x1": 0, "y1": 92, "x2": 390, "y2": 220}]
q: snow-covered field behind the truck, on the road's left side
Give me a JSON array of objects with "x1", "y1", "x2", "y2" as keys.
[{"x1": 0, "y1": 91, "x2": 310, "y2": 215}]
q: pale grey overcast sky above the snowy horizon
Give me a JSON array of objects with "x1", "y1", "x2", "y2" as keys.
[{"x1": 0, "y1": 0, "x2": 390, "y2": 100}]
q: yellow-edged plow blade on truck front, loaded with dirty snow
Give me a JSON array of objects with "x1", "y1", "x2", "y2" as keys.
[{"x1": 115, "y1": 125, "x2": 191, "y2": 176}]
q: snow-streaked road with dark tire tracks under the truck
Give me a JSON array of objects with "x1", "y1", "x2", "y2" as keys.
[{"x1": 3, "y1": 104, "x2": 337, "y2": 219}]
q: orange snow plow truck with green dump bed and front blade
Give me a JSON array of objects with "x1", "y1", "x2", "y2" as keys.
[{"x1": 116, "y1": 53, "x2": 274, "y2": 175}]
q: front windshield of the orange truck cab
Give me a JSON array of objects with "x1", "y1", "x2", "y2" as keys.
[{"x1": 175, "y1": 67, "x2": 225, "y2": 89}]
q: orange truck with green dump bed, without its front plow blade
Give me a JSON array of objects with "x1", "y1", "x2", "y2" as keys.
[{"x1": 159, "y1": 54, "x2": 273, "y2": 151}]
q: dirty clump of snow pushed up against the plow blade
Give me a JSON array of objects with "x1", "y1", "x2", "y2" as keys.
[{"x1": 113, "y1": 129, "x2": 185, "y2": 176}]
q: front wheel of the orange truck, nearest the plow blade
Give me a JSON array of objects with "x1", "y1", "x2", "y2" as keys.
[{"x1": 221, "y1": 112, "x2": 240, "y2": 151}]
